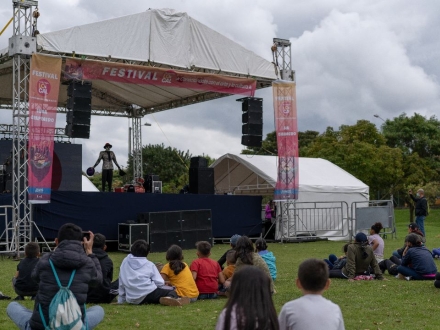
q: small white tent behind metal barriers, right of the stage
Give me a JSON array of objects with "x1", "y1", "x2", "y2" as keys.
[{"x1": 211, "y1": 154, "x2": 369, "y2": 240}]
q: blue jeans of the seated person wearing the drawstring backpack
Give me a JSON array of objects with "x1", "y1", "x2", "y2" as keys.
[{"x1": 6, "y1": 301, "x2": 104, "y2": 330}]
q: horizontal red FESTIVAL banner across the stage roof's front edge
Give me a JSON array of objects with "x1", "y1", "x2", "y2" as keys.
[{"x1": 64, "y1": 59, "x2": 257, "y2": 96}]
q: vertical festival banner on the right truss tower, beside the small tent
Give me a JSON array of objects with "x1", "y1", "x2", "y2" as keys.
[{"x1": 272, "y1": 80, "x2": 299, "y2": 200}]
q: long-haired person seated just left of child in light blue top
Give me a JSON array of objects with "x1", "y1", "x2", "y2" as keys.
[{"x1": 232, "y1": 236, "x2": 274, "y2": 292}]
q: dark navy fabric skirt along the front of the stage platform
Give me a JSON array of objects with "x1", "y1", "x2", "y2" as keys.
[{"x1": 0, "y1": 191, "x2": 262, "y2": 240}]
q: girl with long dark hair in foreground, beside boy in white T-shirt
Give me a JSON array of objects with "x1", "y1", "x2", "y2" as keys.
[{"x1": 215, "y1": 266, "x2": 280, "y2": 330}]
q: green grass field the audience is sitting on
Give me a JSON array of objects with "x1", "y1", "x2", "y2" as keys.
[{"x1": 0, "y1": 209, "x2": 440, "y2": 330}]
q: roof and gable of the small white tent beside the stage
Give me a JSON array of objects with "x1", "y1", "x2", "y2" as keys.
[{"x1": 211, "y1": 154, "x2": 369, "y2": 201}]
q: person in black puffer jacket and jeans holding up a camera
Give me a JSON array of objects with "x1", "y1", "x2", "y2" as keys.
[{"x1": 6, "y1": 223, "x2": 104, "y2": 330}]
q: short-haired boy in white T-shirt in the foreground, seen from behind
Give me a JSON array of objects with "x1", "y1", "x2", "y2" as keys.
[{"x1": 278, "y1": 259, "x2": 345, "y2": 330}]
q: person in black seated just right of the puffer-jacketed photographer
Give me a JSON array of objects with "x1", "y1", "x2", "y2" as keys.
[{"x1": 87, "y1": 233, "x2": 119, "y2": 304}]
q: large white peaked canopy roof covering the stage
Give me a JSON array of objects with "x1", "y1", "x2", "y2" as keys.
[{"x1": 0, "y1": 9, "x2": 277, "y2": 116}]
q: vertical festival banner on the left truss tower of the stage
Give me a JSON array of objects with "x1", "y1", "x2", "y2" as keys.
[{"x1": 28, "y1": 54, "x2": 62, "y2": 204}]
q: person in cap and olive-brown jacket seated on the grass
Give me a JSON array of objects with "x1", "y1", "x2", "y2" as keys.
[{"x1": 330, "y1": 233, "x2": 383, "y2": 281}]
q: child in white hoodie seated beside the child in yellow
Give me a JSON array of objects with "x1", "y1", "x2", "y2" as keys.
[{"x1": 118, "y1": 240, "x2": 189, "y2": 306}]
